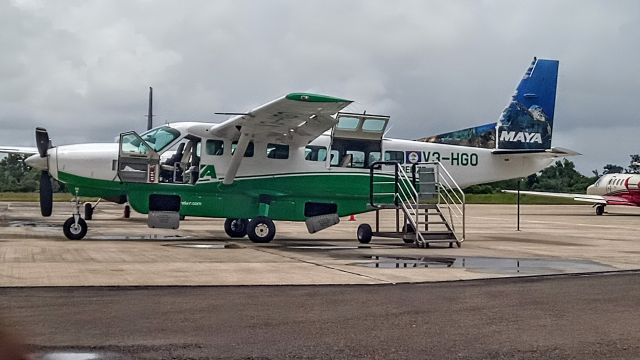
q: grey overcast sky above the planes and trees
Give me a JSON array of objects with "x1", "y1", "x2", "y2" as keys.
[{"x1": 0, "y1": 0, "x2": 640, "y2": 175}]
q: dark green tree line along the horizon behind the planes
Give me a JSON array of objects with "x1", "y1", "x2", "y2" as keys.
[{"x1": 0, "y1": 154, "x2": 640, "y2": 194}]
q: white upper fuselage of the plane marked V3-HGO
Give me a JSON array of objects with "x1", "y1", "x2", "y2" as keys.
[{"x1": 43, "y1": 123, "x2": 554, "y2": 187}]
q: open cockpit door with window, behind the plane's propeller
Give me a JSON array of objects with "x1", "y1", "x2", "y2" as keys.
[{"x1": 118, "y1": 131, "x2": 160, "y2": 183}]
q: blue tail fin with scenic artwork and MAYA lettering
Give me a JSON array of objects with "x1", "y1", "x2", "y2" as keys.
[{"x1": 418, "y1": 58, "x2": 559, "y2": 151}]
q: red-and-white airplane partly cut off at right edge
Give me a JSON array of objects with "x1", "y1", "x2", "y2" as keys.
[{"x1": 502, "y1": 169, "x2": 640, "y2": 215}]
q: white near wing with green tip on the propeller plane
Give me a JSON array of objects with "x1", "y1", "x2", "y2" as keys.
[{"x1": 210, "y1": 93, "x2": 352, "y2": 143}]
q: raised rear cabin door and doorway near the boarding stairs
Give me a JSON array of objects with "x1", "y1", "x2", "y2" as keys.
[{"x1": 329, "y1": 112, "x2": 389, "y2": 168}]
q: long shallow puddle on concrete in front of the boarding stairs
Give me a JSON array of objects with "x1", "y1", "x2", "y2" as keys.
[{"x1": 352, "y1": 255, "x2": 616, "y2": 274}]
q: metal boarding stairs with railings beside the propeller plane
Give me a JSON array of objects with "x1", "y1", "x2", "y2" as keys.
[{"x1": 370, "y1": 161, "x2": 465, "y2": 247}]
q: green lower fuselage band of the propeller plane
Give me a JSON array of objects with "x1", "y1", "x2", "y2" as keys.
[{"x1": 59, "y1": 172, "x2": 393, "y2": 221}]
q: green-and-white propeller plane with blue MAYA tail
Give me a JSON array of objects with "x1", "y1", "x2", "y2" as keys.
[{"x1": 0, "y1": 58, "x2": 576, "y2": 242}]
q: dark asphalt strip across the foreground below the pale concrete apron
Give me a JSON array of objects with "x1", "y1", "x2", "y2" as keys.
[{"x1": 0, "y1": 272, "x2": 640, "y2": 359}]
